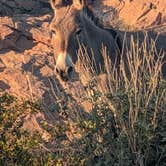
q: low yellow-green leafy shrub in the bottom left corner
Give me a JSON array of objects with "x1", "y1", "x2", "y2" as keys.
[{"x1": 0, "y1": 93, "x2": 57, "y2": 165}]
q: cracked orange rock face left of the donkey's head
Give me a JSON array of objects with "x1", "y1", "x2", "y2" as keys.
[{"x1": 0, "y1": 0, "x2": 52, "y2": 99}]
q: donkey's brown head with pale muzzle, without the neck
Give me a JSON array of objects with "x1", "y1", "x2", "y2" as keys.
[{"x1": 50, "y1": 0, "x2": 92, "y2": 80}]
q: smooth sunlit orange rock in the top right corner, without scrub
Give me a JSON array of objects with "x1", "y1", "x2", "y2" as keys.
[{"x1": 102, "y1": 0, "x2": 166, "y2": 28}]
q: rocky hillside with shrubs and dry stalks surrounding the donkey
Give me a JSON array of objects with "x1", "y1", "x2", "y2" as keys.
[{"x1": 0, "y1": 0, "x2": 166, "y2": 166}]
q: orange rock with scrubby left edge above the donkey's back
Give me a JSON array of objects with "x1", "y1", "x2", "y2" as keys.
[{"x1": 95, "y1": 0, "x2": 166, "y2": 30}]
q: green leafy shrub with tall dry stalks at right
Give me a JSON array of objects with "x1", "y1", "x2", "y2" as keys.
[{"x1": 55, "y1": 35, "x2": 166, "y2": 165}]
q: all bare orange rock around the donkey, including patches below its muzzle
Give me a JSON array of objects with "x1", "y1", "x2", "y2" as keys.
[{"x1": 0, "y1": 0, "x2": 166, "y2": 151}]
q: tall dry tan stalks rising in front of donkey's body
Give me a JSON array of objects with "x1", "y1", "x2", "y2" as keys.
[{"x1": 72, "y1": 34, "x2": 166, "y2": 165}]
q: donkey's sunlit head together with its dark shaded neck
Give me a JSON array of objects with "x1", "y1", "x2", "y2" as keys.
[{"x1": 50, "y1": 0, "x2": 121, "y2": 80}]
